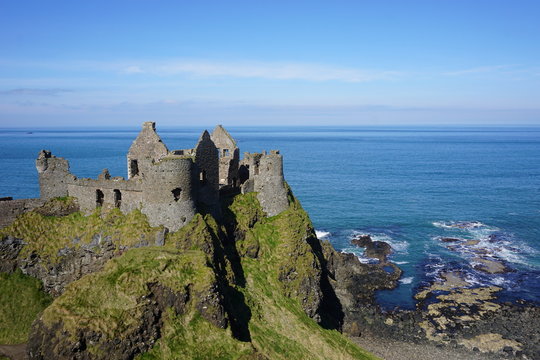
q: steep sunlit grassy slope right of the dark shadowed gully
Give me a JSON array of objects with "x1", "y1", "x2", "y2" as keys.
[{"x1": 232, "y1": 194, "x2": 374, "y2": 359}]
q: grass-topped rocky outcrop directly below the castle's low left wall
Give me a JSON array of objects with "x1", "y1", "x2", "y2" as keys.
[{"x1": 0, "y1": 202, "x2": 164, "y2": 296}]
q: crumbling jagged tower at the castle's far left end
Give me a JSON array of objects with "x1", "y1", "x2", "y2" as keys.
[{"x1": 36, "y1": 150, "x2": 74, "y2": 200}]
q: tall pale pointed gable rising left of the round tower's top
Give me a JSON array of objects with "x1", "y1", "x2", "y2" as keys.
[{"x1": 127, "y1": 121, "x2": 169, "y2": 179}]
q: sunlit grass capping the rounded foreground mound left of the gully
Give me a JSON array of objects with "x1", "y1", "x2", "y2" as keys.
[{"x1": 41, "y1": 247, "x2": 215, "y2": 339}]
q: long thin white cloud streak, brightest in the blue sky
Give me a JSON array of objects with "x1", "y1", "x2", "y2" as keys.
[{"x1": 122, "y1": 61, "x2": 402, "y2": 83}]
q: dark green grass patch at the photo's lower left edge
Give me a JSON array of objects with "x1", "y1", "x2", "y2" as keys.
[{"x1": 0, "y1": 271, "x2": 52, "y2": 344}]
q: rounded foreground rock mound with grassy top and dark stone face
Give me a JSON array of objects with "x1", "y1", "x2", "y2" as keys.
[{"x1": 29, "y1": 247, "x2": 227, "y2": 359}]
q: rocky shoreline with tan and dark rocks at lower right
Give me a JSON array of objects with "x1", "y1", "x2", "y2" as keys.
[{"x1": 351, "y1": 233, "x2": 540, "y2": 359}]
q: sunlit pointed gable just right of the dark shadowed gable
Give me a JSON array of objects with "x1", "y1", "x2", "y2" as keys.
[{"x1": 211, "y1": 125, "x2": 240, "y2": 186}]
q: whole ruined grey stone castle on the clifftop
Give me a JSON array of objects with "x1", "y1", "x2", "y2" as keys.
[{"x1": 32, "y1": 122, "x2": 288, "y2": 231}]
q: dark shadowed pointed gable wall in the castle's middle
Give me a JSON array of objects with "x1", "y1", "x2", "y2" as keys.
[{"x1": 195, "y1": 130, "x2": 221, "y2": 218}]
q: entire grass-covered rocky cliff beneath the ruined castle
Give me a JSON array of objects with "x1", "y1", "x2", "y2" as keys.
[{"x1": 0, "y1": 187, "x2": 399, "y2": 359}]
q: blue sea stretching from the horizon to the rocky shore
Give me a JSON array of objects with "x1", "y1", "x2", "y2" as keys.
[{"x1": 0, "y1": 127, "x2": 540, "y2": 309}]
